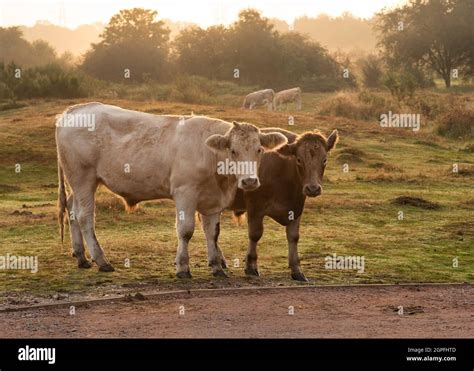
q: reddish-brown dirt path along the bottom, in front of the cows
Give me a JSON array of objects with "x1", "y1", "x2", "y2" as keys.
[{"x1": 0, "y1": 285, "x2": 474, "y2": 338}]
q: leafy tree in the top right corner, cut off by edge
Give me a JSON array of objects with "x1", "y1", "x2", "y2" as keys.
[{"x1": 376, "y1": 0, "x2": 474, "y2": 88}]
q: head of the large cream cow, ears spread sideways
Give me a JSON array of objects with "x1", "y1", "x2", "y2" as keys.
[{"x1": 206, "y1": 121, "x2": 287, "y2": 190}]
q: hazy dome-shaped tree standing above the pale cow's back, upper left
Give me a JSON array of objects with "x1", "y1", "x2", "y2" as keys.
[{"x1": 82, "y1": 8, "x2": 170, "y2": 81}]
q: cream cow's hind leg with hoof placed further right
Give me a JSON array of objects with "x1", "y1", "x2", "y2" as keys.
[{"x1": 73, "y1": 182, "x2": 114, "y2": 272}]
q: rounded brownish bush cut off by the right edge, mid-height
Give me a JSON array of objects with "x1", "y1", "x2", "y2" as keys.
[{"x1": 437, "y1": 105, "x2": 474, "y2": 140}]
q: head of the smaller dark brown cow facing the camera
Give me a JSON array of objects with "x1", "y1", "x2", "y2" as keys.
[{"x1": 278, "y1": 130, "x2": 339, "y2": 197}]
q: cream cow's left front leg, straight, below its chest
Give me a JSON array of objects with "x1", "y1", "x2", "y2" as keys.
[{"x1": 175, "y1": 195, "x2": 196, "y2": 278}]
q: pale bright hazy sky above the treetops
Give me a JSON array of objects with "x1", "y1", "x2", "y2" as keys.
[{"x1": 0, "y1": 0, "x2": 405, "y2": 28}]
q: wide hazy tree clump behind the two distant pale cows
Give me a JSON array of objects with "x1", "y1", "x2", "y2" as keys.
[{"x1": 173, "y1": 9, "x2": 353, "y2": 91}]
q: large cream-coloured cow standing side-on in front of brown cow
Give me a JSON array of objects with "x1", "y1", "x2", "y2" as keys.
[{"x1": 56, "y1": 103, "x2": 287, "y2": 278}]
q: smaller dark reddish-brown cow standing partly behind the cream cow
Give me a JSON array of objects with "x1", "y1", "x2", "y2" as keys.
[{"x1": 230, "y1": 129, "x2": 338, "y2": 281}]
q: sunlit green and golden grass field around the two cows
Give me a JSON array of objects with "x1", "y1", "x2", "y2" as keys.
[{"x1": 0, "y1": 94, "x2": 474, "y2": 295}]
